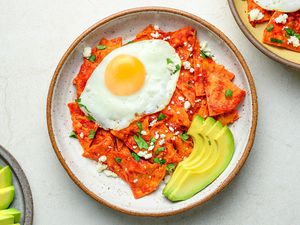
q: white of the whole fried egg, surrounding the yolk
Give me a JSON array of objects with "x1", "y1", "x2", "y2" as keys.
[{"x1": 80, "y1": 40, "x2": 181, "y2": 130}]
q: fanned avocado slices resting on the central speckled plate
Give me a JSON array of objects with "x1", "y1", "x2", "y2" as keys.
[{"x1": 163, "y1": 117, "x2": 234, "y2": 201}]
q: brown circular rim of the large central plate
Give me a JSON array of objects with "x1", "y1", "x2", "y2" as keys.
[{"x1": 46, "y1": 7, "x2": 258, "y2": 217}]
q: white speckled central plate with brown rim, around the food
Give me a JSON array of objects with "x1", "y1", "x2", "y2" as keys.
[{"x1": 47, "y1": 7, "x2": 257, "y2": 216}]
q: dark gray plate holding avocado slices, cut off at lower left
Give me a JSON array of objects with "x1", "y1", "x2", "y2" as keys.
[{"x1": 0, "y1": 145, "x2": 33, "y2": 225}]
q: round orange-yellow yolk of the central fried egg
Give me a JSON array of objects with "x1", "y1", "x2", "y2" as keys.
[{"x1": 105, "y1": 54, "x2": 146, "y2": 96}]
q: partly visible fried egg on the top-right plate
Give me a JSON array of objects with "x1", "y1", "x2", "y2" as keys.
[{"x1": 255, "y1": 0, "x2": 300, "y2": 12}]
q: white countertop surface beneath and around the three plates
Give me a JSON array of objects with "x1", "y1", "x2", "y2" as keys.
[{"x1": 0, "y1": 0, "x2": 300, "y2": 225}]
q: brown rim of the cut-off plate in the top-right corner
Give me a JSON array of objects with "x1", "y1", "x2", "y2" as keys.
[{"x1": 228, "y1": 0, "x2": 300, "y2": 70}]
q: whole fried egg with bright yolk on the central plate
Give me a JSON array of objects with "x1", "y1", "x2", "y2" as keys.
[{"x1": 80, "y1": 40, "x2": 181, "y2": 130}]
